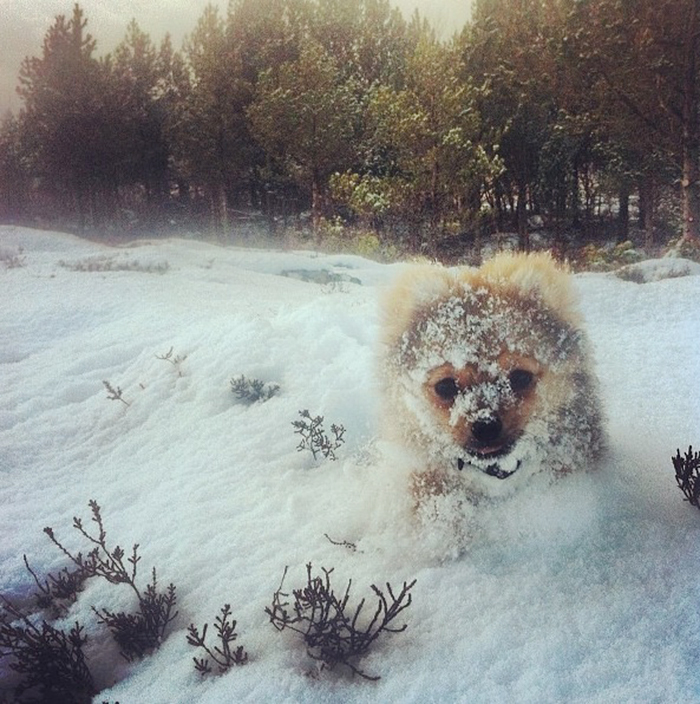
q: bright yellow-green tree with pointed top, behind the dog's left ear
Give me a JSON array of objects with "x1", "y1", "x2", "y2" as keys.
[{"x1": 333, "y1": 32, "x2": 499, "y2": 247}]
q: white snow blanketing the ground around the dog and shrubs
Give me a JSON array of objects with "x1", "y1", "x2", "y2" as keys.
[{"x1": 0, "y1": 227, "x2": 700, "y2": 704}]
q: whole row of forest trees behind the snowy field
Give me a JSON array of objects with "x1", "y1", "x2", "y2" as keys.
[{"x1": 0, "y1": 0, "x2": 700, "y2": 249}]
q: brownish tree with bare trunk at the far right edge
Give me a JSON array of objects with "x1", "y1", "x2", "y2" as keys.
[{"x1": 571, "y1": 0, "x2": 700, "y2": 241}]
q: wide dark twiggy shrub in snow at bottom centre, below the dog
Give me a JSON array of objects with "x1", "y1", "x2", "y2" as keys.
[{"x1": 265, "y1": 563, "x2": 416, "y2": 680}]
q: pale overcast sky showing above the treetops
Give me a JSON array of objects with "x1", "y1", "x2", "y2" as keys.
[{"x1": 0, "y1": 0, "x2": 471, "y2": 116}]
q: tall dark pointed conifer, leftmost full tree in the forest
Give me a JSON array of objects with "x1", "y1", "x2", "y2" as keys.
[{"x1": 19, "y1": 4, "x2": 119, "y2": 229}]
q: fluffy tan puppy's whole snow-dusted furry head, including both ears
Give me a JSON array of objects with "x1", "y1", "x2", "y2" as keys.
[{"x1": 381, "y1": 254, "x2": 603, "y2": 501}]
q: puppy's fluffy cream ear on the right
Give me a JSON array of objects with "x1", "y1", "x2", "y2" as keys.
[{"x1": 479, "y1": 252, "x2": 579, "y2": 324}]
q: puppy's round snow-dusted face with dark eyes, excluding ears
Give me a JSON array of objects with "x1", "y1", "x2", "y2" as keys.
[{"x1": 384, "y1": 253, "x2": 597, "y2": 494}]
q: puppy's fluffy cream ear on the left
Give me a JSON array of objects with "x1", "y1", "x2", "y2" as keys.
[{"x1": 381, "y1": 264, "x2": 453, "y2": 345}]
